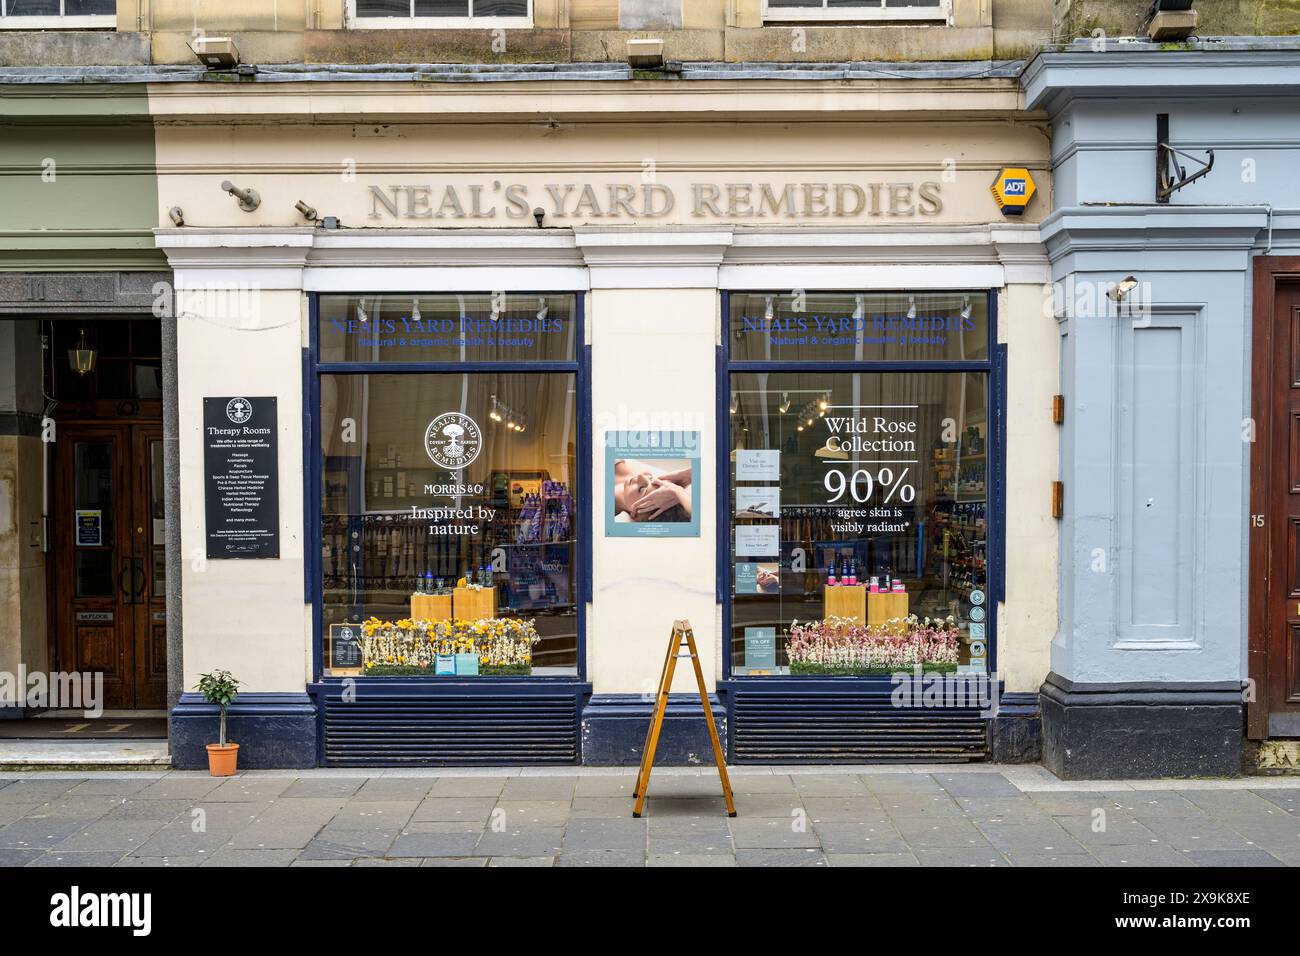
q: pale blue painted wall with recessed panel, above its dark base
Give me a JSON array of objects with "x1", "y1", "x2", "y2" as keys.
[{"x1": 1024, "y1": 40, "x2": 1300, "y2": 683}]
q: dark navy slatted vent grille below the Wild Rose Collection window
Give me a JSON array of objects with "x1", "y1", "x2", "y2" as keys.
[{"x1": 731, "y1": 688, "x2": 988, "y2": 763}]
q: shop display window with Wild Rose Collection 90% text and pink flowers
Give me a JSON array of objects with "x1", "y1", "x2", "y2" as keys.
[{"x1": 724, "y1": 293, "x2": 997, "y2": 676}]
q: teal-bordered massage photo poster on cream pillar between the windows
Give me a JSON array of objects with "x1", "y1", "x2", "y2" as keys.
[{"x1": 605, "y1": 431, "x2": 702, "y2": 537}]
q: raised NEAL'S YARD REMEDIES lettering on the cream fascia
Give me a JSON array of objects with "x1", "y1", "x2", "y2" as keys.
[{"x1": 368, "y1": 179, "x2": 944, "y2": 221}]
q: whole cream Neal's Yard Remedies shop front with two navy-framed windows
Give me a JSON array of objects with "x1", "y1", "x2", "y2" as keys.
[{"x1": 153, "y1": 72, "x2": 1057, "y2": 766}]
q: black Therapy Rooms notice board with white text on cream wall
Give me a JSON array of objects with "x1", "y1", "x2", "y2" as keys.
[{"x1": 203, "y1": 395, "x2": 280, "y2": 558}]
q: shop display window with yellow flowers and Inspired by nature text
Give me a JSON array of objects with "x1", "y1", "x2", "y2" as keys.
[{"x1": 316, "y1": 294, "x2": 588, "y2": 678}]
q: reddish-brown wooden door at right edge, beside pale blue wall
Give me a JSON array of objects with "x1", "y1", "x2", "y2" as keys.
[{"x1": 1249, "y1": 269, "x2": 1300, "y2": 737}]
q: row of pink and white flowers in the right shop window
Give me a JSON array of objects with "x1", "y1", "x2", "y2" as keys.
[{"x1": 788, "y1": 615, "x2": 961, "y2": 674}]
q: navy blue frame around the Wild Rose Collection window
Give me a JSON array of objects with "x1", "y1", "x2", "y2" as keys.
[{"x1": 715, "y1": 289, "x2": 1006, "y2": 687}]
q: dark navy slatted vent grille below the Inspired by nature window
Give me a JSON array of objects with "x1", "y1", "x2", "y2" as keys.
[{"x1": 322, "y1": 692, "x2": 579, "y2": 767}]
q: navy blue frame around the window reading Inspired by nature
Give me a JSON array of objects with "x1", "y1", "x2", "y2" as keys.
[{"x1": 303, "y1": 289, "x2": 593, "y2": 687}]
